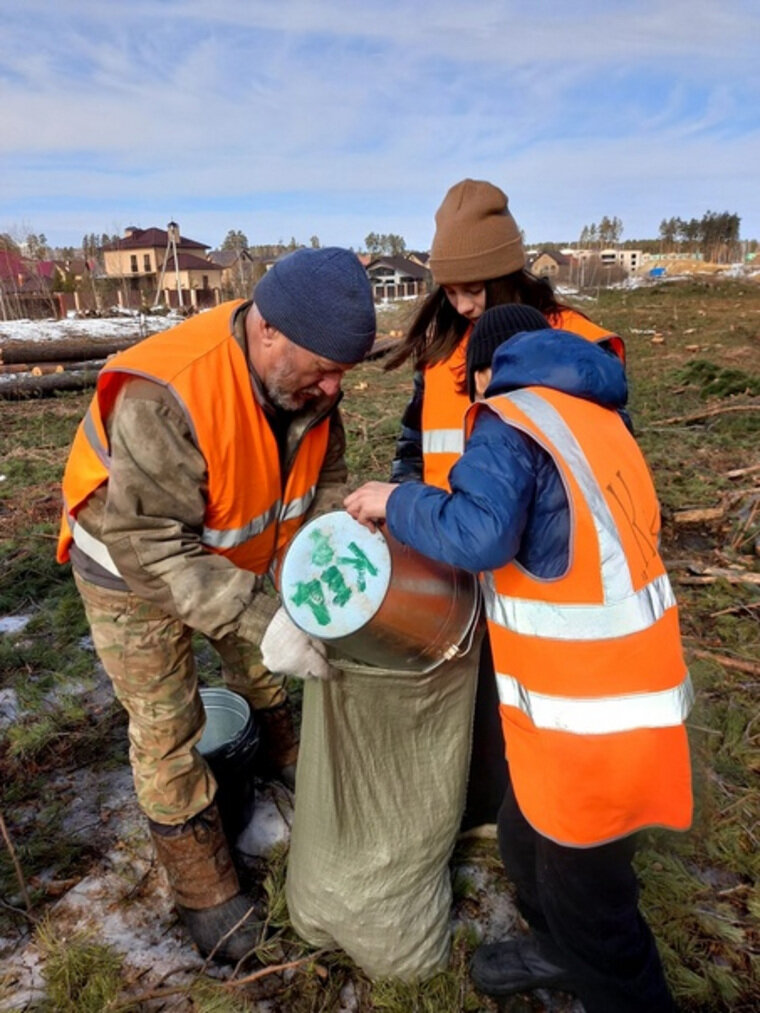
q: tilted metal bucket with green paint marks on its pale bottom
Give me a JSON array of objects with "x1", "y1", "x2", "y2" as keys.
[{"x1": 280, "y1": 511, "x2": 478, "y2": 673}]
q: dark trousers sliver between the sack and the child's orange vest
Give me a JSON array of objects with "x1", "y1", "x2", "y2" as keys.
[{"x1": 461, "y1": 630, "x2": 508, "y2": 831}]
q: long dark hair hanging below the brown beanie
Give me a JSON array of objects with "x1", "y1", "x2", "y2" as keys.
[{"x1": 385, "y1": 267, "x2": 567, "y2": 370}]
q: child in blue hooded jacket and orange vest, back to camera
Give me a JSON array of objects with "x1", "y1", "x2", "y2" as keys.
[{"x1": 345, "y1": 304, "x2": 692, "y2": 1013}]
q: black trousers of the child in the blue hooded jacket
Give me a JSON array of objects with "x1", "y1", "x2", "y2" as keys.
[{"x1": 499, "y1": 784, "x2": 676, "y2": 1013}]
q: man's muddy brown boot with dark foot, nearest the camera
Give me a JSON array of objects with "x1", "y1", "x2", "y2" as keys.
[{"x1": 149, "y1": 804, "x2": 261, "y2": 963}]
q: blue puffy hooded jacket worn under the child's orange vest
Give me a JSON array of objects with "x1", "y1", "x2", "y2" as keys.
[{"x1": 387, "y1": 327, "x2": 627, "y2": 578}]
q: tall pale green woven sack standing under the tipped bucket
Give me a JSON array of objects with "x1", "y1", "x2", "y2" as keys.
[{"x1": 287, "y1": 634, "x2": 480, "y2": 981}]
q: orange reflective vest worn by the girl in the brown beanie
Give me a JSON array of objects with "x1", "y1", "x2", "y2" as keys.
[{"x1": 423, "y1": 309, "x2": 625, "y2": 490}]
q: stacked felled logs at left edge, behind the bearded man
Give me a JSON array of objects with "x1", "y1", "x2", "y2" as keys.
[{"x1": 0, "y1": 334, "x2": 140, "y2": 399}]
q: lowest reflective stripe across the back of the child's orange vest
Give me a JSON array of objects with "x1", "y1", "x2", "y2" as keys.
[{"x1": 497, "y1": 672, "x2": 694, "y2": 735}]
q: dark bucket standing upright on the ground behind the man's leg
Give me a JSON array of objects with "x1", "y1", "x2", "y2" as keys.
[{"x1": 197, "y1": 687, "x2": 258, "y2": 843}]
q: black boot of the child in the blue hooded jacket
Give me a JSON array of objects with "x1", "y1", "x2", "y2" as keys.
[{"x1": 470, "y1": 935, "x2": 572, "y2": 998}]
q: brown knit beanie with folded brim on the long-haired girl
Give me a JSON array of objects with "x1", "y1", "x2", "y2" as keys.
[{"x1": 430, "y1": 179, "x2": 525, "y2": 285}]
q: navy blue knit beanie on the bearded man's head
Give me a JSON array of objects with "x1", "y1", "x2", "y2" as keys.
[{"x1": 253, "y1": 246, "x2": 375, "y2": 363}]
